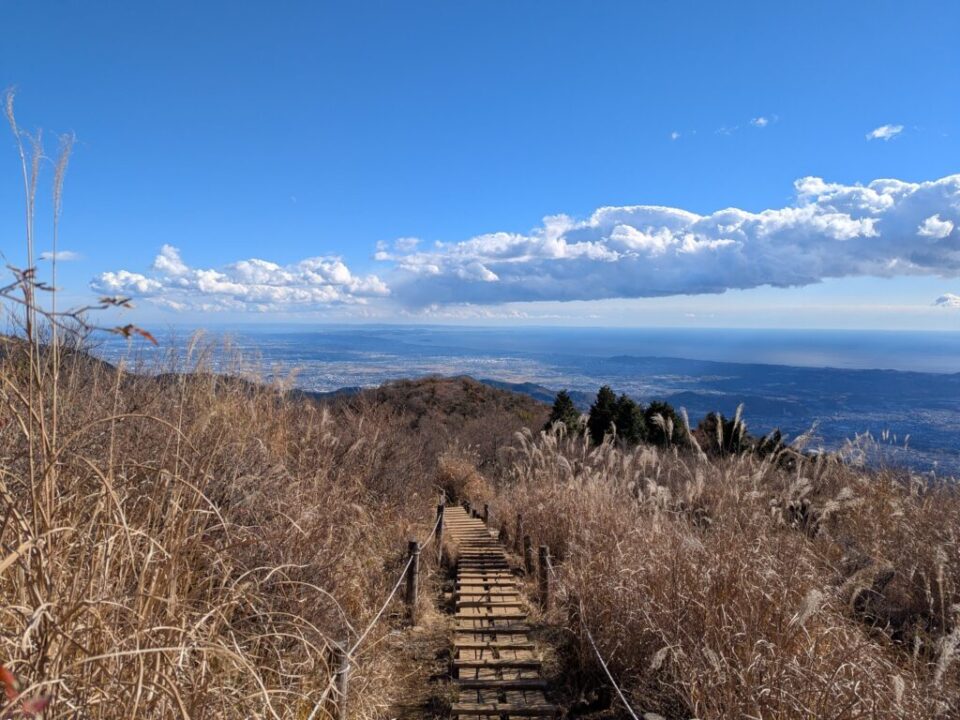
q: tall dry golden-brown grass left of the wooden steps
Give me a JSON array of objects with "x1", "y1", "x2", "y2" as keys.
[{"x1": 0, "y1": 334, "x2": 435, "y2": 718}]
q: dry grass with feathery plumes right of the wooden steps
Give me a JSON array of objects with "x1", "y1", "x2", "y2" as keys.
[{"x1": 495, "y1": 434, "x2": 960, "y2": 719}]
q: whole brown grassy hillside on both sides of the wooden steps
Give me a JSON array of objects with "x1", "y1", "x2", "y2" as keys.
[{"x1": 0, "y1": 330, "x2": 960, "y2": 719}]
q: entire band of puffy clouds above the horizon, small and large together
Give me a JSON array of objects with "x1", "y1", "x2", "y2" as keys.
[{"x1": 92, "y1": 174, "x2": 960, "y2": 311}]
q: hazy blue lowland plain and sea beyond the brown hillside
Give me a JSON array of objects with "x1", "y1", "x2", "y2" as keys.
[{"x1": 92, "y1": 325, "x2": 960, "y2": 473}]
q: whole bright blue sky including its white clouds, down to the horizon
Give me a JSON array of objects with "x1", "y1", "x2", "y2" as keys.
[{"x1": 0, "y1": 0, "x2": 960, "y2": 329}]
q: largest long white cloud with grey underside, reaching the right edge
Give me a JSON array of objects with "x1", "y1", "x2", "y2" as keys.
[{"x1": 376, "y1": 175, "x2": 960, "y2": 307}]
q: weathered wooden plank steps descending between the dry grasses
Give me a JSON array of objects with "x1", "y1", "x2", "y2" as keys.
[{"x1": 443, "y1": 506, "x2": 560, "y2": 720}]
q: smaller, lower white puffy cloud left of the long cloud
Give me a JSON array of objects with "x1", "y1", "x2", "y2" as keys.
[{"x1": 91, "y1": 245, "x2": 389, "y2": 312}]
